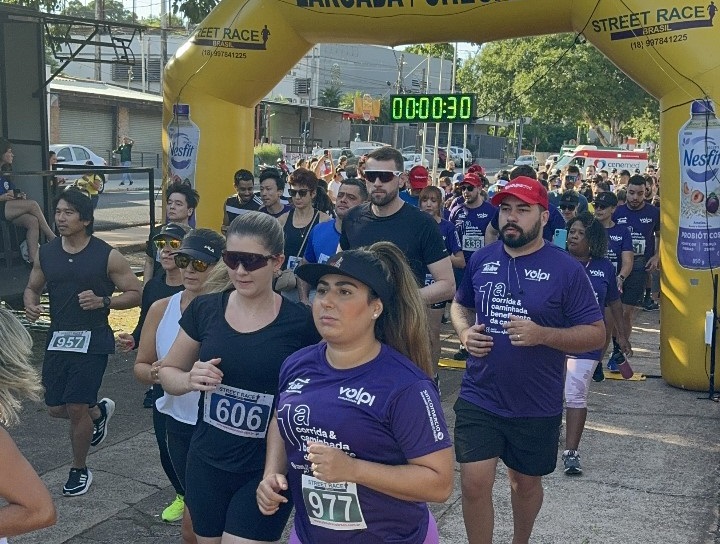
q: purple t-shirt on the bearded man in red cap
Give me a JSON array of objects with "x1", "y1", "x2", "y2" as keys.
[{"x1": 455, "y1": 242, "x2": 603, "y2": 417}]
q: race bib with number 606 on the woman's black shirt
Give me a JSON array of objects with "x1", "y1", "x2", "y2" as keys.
[{"x1": 203, "y1": 384, "x2": 273, "y2": 438}]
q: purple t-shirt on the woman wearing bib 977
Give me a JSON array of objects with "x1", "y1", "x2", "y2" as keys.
[{"x1": 277, "y1": 342, "x2": 452, "y2": 544}]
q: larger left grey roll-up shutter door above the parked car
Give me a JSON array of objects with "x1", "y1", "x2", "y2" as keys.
[{"x1": 58, "y1": 103, "x2": 115, "y2": 164}]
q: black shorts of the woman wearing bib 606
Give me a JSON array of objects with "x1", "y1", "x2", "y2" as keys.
[{"x1": 185, "y1": 452, "x2": 293, "y2": 542}]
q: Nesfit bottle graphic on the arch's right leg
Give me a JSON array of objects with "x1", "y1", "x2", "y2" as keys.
[{"x1": 677, "y1": 99, "x2": 720, "y2": 270}]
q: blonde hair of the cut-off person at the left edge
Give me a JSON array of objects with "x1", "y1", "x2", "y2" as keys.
[{"x1": 0, "y1": 308, "x2": 43, "y2": 426}]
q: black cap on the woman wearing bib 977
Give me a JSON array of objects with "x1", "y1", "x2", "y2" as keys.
[{"x1": 295, "y1": 250, "x2": 394, "y2": 305}]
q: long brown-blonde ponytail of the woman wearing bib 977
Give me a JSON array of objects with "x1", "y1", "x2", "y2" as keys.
[{"x1": 368, "y1": 242, "x2": 433, "y2": 376}]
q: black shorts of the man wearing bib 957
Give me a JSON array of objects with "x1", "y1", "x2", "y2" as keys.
[{"x1": 42, "y1": 351, "x2": 108, "y2": 406}]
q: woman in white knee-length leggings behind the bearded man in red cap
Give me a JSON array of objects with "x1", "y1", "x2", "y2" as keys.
[{"x1": 562, "y1": 212, "x2": 632, "y2": 475}]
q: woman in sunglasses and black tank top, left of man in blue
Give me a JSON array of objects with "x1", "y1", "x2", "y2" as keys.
[{"x1": 278, "y1": 168, "x2": 330, "y2": 302}]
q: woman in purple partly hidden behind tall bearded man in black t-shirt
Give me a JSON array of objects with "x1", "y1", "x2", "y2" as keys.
[{"x1": 419, "y1": 185, "x2": 465, "y2": 387}]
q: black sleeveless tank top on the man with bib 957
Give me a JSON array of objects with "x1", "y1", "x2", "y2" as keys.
[{"x1": 40, "y1": 236, "x2": 115, "y2": 354}]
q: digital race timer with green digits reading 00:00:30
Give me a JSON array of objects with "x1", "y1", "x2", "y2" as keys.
[{"x1": 390, "y1": 93, "x2": 475, "y2": 123}]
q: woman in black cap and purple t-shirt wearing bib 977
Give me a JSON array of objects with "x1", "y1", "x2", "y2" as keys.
[{"x1": 257, "y1": 242, "x2": 454, "y2": 544}]
